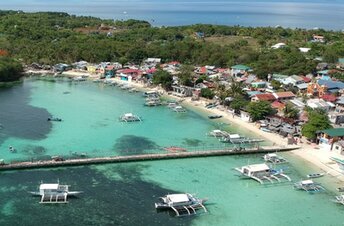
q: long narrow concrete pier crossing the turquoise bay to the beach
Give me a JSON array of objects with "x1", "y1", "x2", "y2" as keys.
[{"x1": 0, "y1": 145, "x2": 300, "y2": 170}]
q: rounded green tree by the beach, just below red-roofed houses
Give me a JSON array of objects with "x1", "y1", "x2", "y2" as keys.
[{"x1": 247, "y1": 101, "x2": 275, "y2": 121}]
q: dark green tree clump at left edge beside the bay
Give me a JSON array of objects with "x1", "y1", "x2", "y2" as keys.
[{"x1": 0, "y1": 56, "x2": 23, "y2": 82}]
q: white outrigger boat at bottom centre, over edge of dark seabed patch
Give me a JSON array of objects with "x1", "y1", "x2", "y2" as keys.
[{"x1": 155, "y1": 193, "x2": 207, "y2": 217}]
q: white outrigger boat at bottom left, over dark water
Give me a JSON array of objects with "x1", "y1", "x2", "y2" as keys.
[{"x1": 30, "y1": 183, "x2": 83, "y2": 203}]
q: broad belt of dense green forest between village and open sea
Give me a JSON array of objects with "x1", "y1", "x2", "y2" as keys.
[{"x1": 0, "y1": 11, "x2": 344, "y2": 79}]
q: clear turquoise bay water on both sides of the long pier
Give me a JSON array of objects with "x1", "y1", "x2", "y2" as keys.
[{"x1": 0, "y1": 79, "x2": 344, "y2": 226}]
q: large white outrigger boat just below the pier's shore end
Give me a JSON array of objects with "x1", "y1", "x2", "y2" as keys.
[{"x1": 235, "y1": 163, "x2": 291, "y2": 184}]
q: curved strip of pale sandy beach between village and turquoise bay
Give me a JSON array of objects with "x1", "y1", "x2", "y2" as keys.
[{"x1": 27, "y1": 71, "x2": 344, "y2": 185}]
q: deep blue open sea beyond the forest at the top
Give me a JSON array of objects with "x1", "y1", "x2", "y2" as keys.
[{"x1": 0, "y1": 0, "x2": 344, "y2": 30}]
